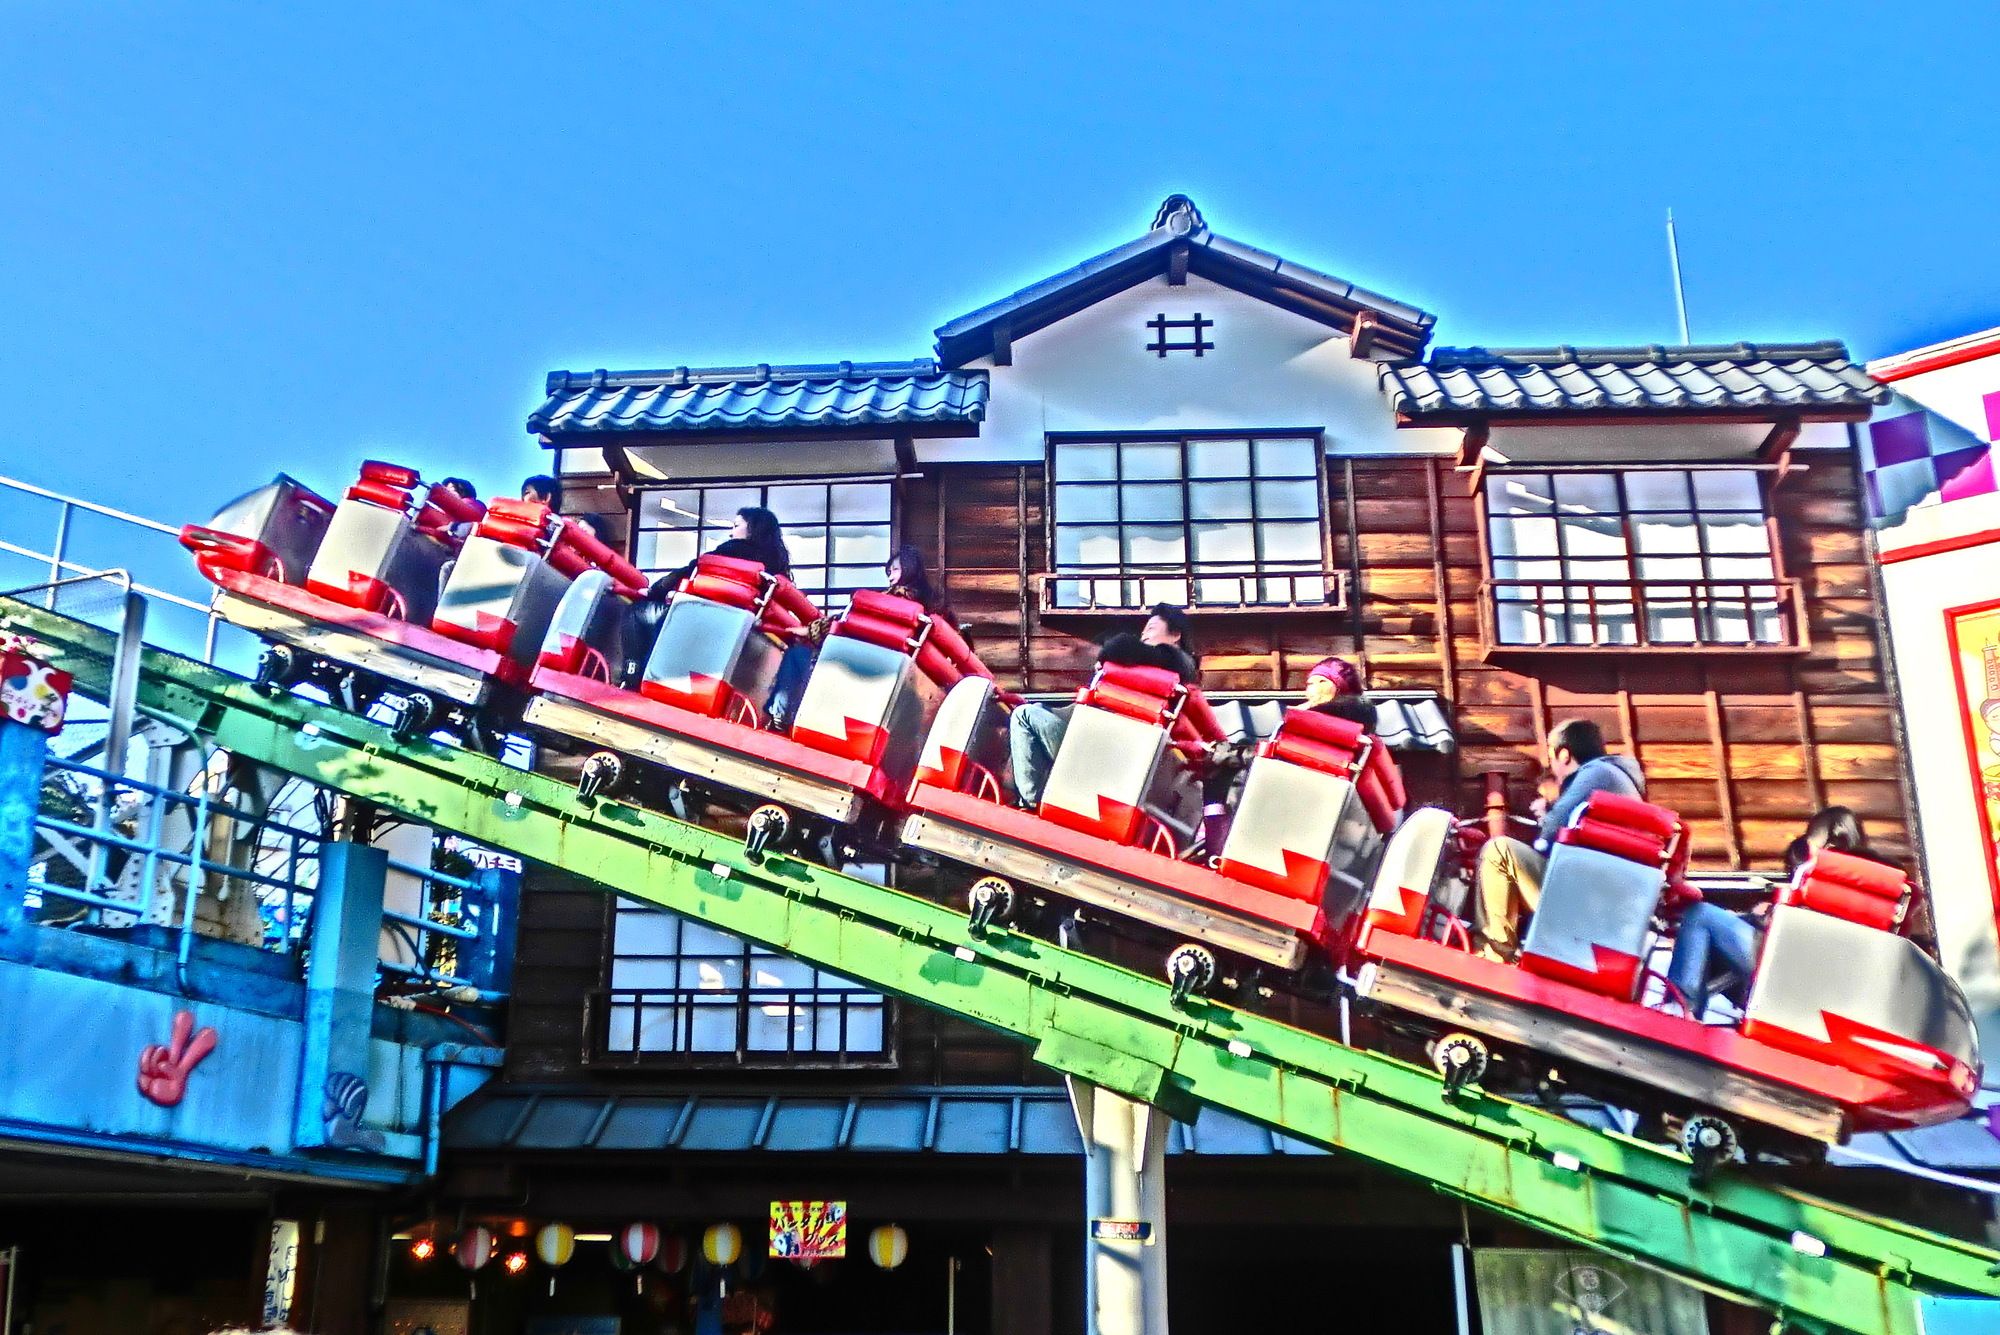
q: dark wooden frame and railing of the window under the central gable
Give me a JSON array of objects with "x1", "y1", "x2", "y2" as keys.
[{"x1": 1038, "y1": 428, "x2": 1350, "y2": 618}]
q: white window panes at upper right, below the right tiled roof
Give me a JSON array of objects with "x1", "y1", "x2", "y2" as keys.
[{"x1": 1486, "y1": 468, "x2": 1792, "y2": 648}]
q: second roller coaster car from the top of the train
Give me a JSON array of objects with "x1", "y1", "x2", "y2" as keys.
[{"x1": 524, "y1": 556, "x2": 988, "y2": 851}]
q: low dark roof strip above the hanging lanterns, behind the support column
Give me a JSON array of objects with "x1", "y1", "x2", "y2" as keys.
[{"x1": 444, "y1": 1085, "x2": 1326, "y2": 1157}]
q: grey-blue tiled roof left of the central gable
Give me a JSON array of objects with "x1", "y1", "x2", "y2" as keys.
[{"x1": 528, "y1": 360, "x2": 986, "y2": 436}]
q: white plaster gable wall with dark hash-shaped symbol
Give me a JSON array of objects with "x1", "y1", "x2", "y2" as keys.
[{"x1": 916, "y1": 276, "x2": 1458, "y2": 464}]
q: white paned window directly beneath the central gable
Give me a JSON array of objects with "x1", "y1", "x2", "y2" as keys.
[{"x1": 1048, "y1": 436, "x2": 1336, "y2": 608}]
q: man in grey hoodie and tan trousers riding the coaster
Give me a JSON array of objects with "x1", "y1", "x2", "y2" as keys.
[{"x1": 1472, "y1": 719, "x2": 1646, "y2": 963}]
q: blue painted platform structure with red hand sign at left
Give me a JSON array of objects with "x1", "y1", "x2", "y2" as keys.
[{"x1": 0, "y1": 721, "x2": 498, "y2": 1187}]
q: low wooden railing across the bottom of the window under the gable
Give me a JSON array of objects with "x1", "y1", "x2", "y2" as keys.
[{"x1": 1038, "y1": 562, "x2": 1348, "y2": 612}]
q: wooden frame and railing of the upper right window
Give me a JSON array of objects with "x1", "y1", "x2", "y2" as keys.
[{"x1": 1478, "y1": 462, "x2": 1812, "y2": 660}]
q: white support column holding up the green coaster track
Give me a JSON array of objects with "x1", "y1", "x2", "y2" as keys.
[{"x1": 1066, "y1": 1077, "x2": 1168, "y2": 1335}]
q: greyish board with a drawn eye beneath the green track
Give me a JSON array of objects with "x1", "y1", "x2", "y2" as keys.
[{"x1": 1472, "y1": 1247, "x2": 1708, "y2": 1335}]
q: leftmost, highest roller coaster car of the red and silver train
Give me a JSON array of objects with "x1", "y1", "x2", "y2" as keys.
[{"x1": 180, "y1": 462, "x2": 646, "y2": 733}]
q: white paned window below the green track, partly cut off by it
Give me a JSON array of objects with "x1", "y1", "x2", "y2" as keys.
[{"x1": 596, "y1": 899, "x2": 890, "y2": 1065}]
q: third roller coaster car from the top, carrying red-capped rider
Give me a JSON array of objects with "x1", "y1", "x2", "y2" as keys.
[{"x1": 902, "y1": 664, "x2": 1404, "y2": 999}]
